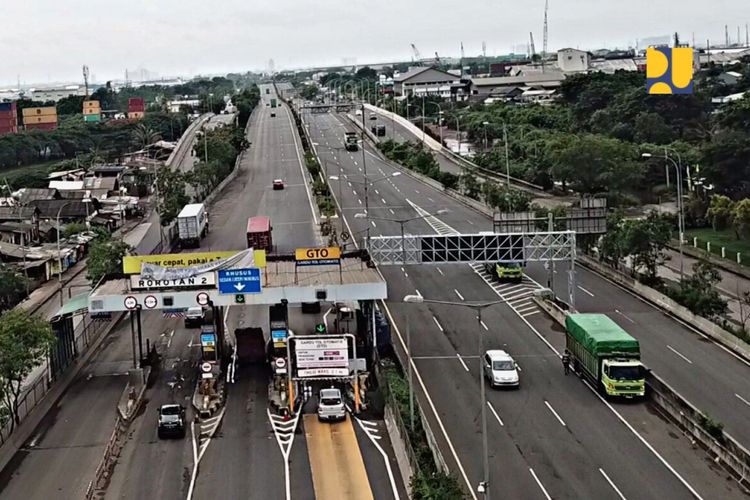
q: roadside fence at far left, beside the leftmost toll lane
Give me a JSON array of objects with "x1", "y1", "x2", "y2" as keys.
[{"x1": 0, "y1": 314, "x2": 114, "y2": 446}]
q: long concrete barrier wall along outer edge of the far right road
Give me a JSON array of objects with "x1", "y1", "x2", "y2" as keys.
[{"x1": 576, "y1": 253, "x2": 750, "y2": 359}]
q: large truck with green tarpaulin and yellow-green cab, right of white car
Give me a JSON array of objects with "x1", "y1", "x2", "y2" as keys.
[{"x1": 565, "y1": 314, "x2": 646, "y2": 397}]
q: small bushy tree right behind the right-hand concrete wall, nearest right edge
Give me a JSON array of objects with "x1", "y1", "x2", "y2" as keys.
[{"x1": 670, "y1": 259, "x2": 728, "y2": 320}]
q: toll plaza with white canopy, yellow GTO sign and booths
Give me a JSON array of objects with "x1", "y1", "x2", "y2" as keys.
[{"x1": 88, "y1": 247, "x2": 387, "y2": 416}]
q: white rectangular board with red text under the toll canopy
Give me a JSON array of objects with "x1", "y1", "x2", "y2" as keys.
[{"x1": 295, "y1": 338, "x2": 349, "y2": 377}]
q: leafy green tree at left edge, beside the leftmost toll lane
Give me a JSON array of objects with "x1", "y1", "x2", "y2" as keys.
[{"x1": 0, "y1": 309, "x2": 55, "y2": 428}]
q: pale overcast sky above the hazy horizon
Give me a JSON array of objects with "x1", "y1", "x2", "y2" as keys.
[{"x1": 0, "y1": 0, "x2": 750, "y2": 86}]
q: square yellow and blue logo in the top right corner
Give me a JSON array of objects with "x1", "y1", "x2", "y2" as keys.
[{"x1": 646, "y1": 47, "x2": 693, "y2": 94}]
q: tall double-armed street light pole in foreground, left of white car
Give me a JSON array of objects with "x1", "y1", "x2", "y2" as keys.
[{"x1": 403, "y1": 295, "x2": 508, "y2": 500}]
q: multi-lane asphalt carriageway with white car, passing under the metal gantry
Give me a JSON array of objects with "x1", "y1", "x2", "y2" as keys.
[{"x1": 306, "y1": 109, "x2": 738, "y2": 498}]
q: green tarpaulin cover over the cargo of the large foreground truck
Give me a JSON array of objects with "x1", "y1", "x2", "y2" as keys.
[{"x1": 565, "y1": 314, "x2": 640, "y2": 356}]
